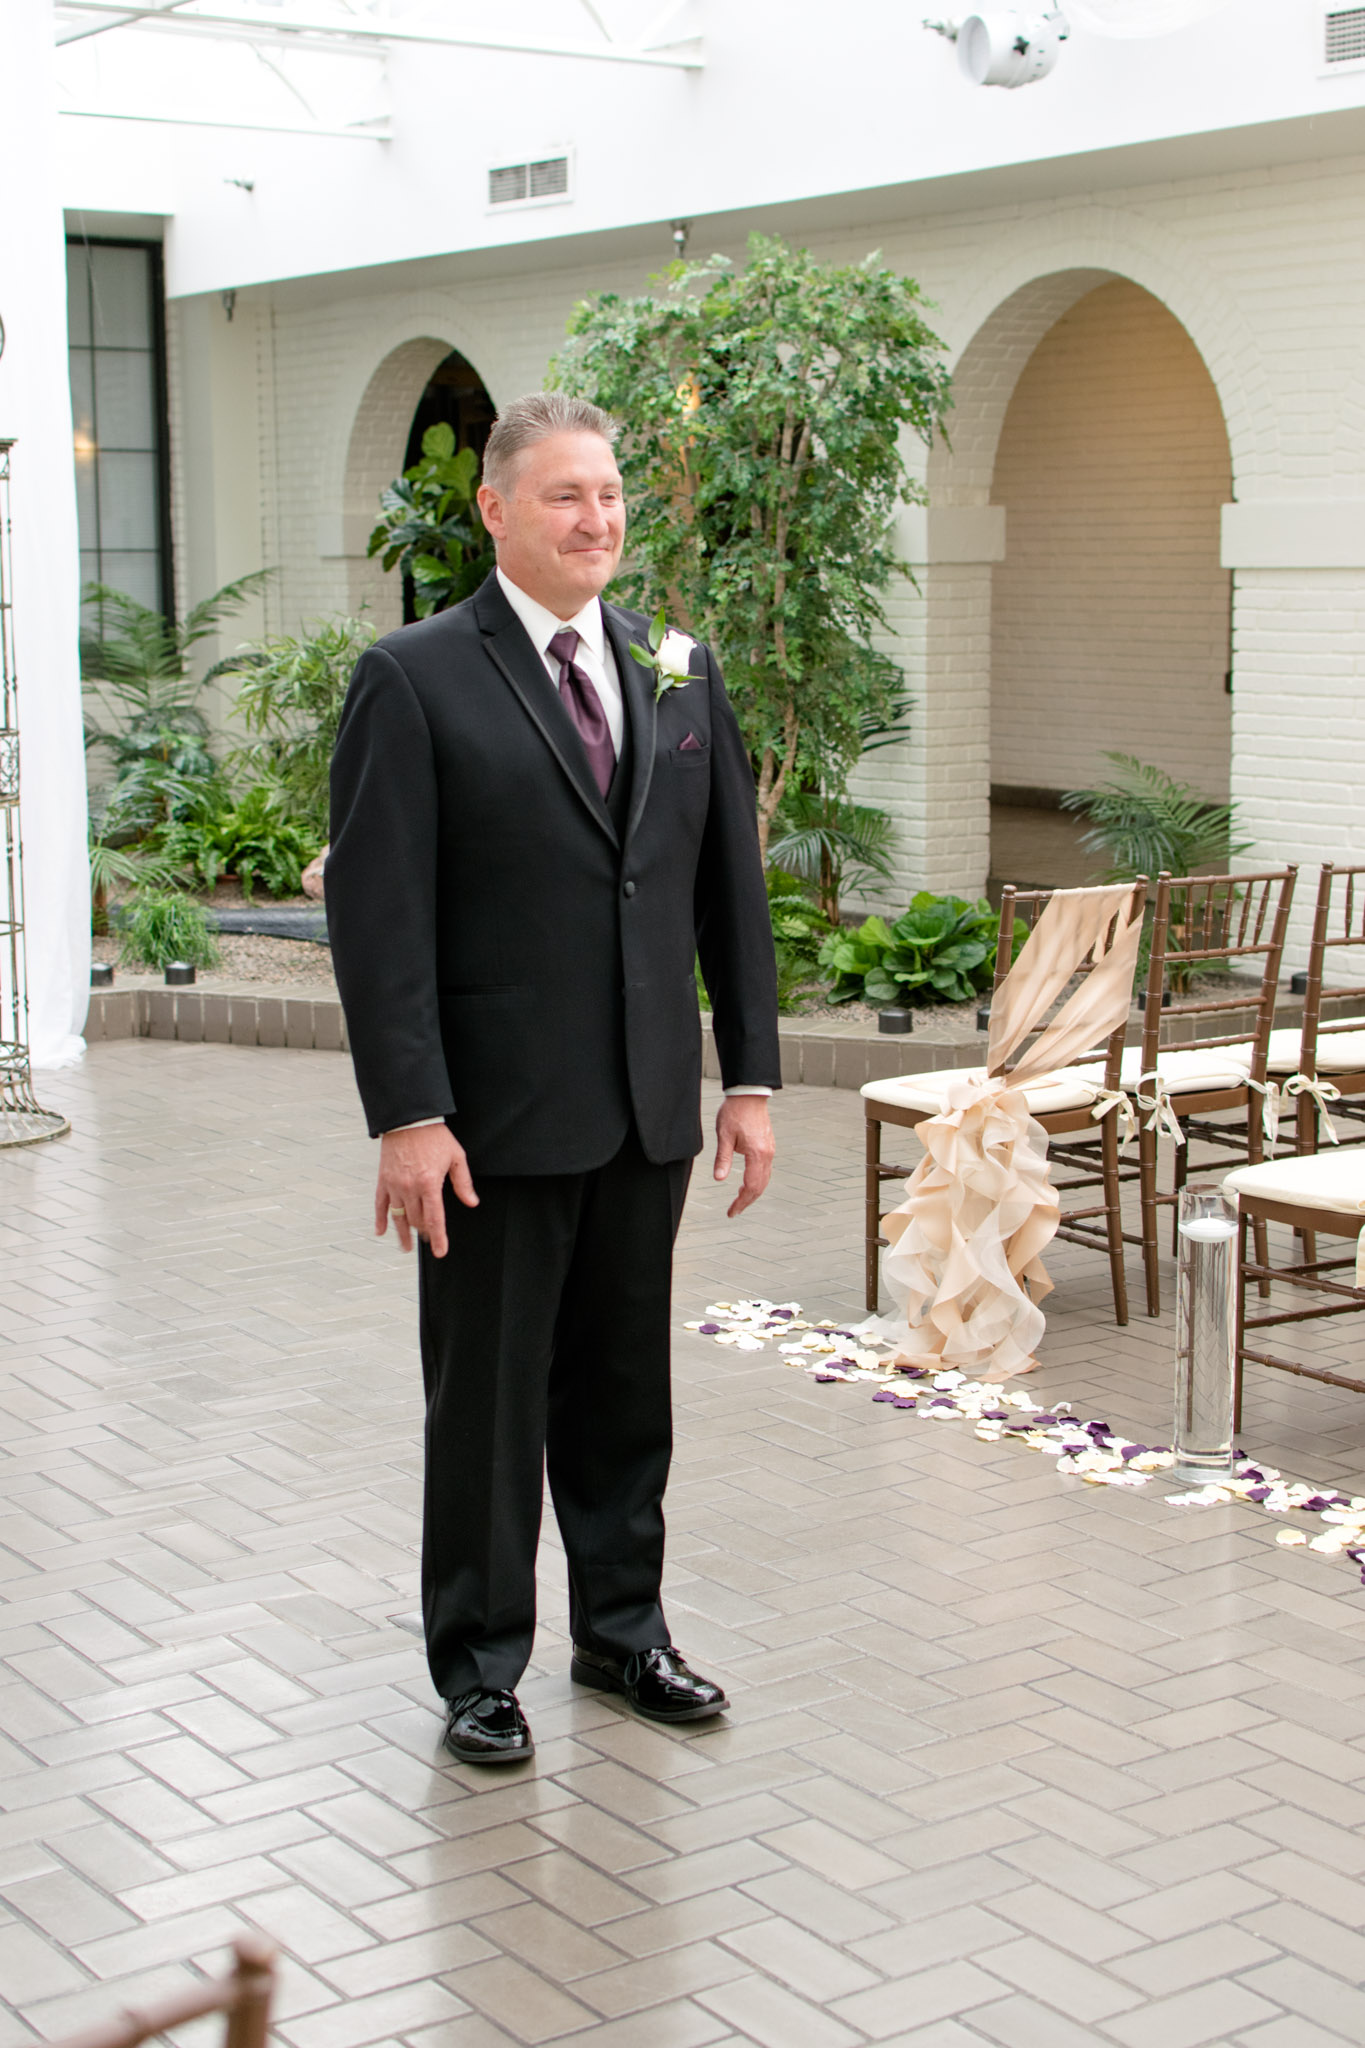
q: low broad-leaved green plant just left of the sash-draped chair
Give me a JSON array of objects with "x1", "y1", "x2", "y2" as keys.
[{"x1": 821, "y1": 889, "x2": 1010, "y2": 1008}]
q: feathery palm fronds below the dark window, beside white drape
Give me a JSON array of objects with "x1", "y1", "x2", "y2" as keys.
[{"x1": 80, "y1": 569, "x2": 268, "y2": 842}]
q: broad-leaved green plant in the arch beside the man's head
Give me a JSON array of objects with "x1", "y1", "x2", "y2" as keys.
[{"x1": 366, "y1": 420, "x2": 493, "y2": 618}]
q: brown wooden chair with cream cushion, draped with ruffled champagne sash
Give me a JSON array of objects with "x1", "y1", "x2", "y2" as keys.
[{"x1": 862, "y1": 874, "x2": 1148, "y2": 1323}]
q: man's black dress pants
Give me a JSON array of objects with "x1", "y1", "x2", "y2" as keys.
[{"x1": 420, "y1": 1130, "x2": 692, "y2": 1700}]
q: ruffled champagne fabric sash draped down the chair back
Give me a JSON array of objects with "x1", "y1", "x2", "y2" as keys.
[{"x1": 864, "y1": 885, "x2": 1142, "y2": 1380}]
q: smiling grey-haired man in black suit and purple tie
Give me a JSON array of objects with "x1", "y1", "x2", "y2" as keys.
[{"x1": 327, "y1": 393, "x2": 780, "y2": 1763}]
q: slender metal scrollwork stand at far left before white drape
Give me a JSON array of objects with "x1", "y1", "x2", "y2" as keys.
[{"x1": 0, "y1": 438, "x2": 72, "y2": 1145}]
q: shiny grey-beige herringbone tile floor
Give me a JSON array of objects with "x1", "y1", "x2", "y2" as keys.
[{"x1": 0, "y1": 1040, "x2": 1365, "y2": 2048}]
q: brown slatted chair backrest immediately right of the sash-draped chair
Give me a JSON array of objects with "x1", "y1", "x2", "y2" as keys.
[{"x1": 1142, "y1": 866, "x2": 1297, "y2": 1081}]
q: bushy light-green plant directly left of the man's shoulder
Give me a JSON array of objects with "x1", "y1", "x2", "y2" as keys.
[{"x1": 205, "y1": 618, "x2": 375, "y2": 840}]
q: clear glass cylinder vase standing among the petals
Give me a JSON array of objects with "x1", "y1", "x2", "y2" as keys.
[{"x1": 1173, "y1": 1186, "x2": 1238, "y2": 1485}]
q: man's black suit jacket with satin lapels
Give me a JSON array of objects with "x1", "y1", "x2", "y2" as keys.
[{"x1": 327, "y1": 575, "x2": 780, "y2": 1174}]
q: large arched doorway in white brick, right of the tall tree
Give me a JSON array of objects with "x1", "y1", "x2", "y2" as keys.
[{"x1": 990, "y1": 279, "x2": 1232, "y2": 885}]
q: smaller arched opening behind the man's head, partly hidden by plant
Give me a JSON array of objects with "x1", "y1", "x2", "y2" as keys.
[{"x1": 344, "y1": 334, "x2": 493, "y2": 633}]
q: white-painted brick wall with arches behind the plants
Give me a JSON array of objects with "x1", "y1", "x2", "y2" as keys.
[{"x1": 167, "y1": 158, "x2": 1365, "y2": 950}]
